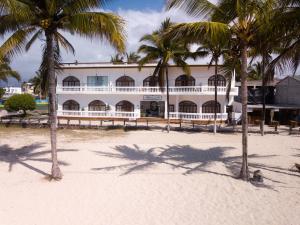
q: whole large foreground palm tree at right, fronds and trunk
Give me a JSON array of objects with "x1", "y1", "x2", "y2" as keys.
[{"x1": 167, "y1": 0, "x2": 268, "y2": 181}]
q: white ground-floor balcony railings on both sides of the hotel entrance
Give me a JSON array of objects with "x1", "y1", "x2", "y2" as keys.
[{"x1": 57, "y1": 110, "x2": 227, "y2": 121}]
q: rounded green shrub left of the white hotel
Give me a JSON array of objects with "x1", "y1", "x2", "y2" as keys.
[{"x1": 4, "y1": 94, "x2": 36, "y2": 115}]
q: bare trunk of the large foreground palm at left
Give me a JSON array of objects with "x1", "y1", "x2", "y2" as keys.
[{"x1": 46, "y1": 31, "x2": 62, "y2": 180}]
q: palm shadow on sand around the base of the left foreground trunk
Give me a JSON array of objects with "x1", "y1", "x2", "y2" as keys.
[{"x1": 0, "y1": 143, "x2": 77, "y2": 176}]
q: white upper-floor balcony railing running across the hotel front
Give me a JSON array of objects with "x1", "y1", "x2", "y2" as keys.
[{"x1": 57, "y1": 85, "x2": 238, "y2": 95}]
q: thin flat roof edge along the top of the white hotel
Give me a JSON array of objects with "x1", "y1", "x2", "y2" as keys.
[{"x1": 60, "y1": 62, "x2": 216, "y2": 69}]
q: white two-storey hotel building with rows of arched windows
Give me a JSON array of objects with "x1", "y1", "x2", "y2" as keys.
[{"x1": 57, "y1": 63, "x2": 238, "y2": 121}]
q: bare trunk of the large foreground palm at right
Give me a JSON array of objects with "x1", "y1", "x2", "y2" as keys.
[{"x1": 240, "y1": 43, "x2": 249, "y2": 181}]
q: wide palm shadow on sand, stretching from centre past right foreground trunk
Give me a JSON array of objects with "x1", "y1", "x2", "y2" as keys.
[{"x1": 92, "y1": 145, "x2": 300, "y2": 189}]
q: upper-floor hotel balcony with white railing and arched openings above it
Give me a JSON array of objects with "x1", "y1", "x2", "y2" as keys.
[{"x1": 57, "y1": 75, "x2": 238, "y2": 95}]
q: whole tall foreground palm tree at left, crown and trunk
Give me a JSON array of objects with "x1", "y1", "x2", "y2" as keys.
[{"x1": 0, "y1": 0, "x2": 125, "y2": 179}]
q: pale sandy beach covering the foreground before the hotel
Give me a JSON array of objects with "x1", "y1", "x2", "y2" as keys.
[{"x1": 0, "y1": 128, "x2": 300, "y2": 225}]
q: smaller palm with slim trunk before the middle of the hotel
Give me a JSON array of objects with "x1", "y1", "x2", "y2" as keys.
[{"x1": 138, "y1": 18, "x2": 190, "y2": 132}]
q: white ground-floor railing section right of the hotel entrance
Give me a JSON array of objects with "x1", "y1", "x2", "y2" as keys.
[{"x1": 170, "y1": 112, "x2": 227, "y2": 121}]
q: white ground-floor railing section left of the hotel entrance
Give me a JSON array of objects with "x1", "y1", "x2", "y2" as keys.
[{"x1": 57, "y1": 110, "x2": 139, "y2": 119}]
